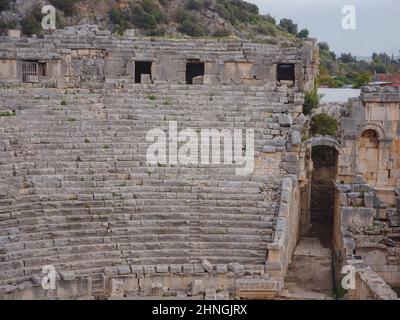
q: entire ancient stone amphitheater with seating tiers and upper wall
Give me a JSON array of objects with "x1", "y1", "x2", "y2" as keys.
[{"x1": 0, "y1": 26, "x2": 400, "y2": 299}]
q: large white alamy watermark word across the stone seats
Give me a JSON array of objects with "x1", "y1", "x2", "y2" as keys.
[{"x1": 146, "y1": 121, "x2": 254, "y2": 176}]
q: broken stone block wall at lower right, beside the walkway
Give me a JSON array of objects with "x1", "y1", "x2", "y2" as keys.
[{"x1": 334, "y1": 184, "x2": 400, "y2": 300}]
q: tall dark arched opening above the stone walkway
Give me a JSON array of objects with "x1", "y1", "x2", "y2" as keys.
[{"x1": 309, "y1": 146, "x2": 338, "y2": 248}]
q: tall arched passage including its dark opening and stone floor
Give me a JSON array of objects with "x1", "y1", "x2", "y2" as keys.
[{"x1": 285, "y1": 146, "x2": 338, "y2": 300}]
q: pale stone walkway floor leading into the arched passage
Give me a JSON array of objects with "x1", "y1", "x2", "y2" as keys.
[{"x1": 282, "y1": 237, "x2": 334, "y2": 300}]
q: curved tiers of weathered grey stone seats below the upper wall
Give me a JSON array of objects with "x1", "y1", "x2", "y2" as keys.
[{"x1": 0, "y1": 86, "x2": 290, "y2": 284}]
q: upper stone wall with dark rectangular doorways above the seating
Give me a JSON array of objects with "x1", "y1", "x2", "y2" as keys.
[{"x1": 0, "y1": 26, "x2": 318, "y2": 89}]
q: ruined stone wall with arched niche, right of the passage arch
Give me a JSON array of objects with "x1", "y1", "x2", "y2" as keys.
[{"x1": 341, "y1": 87, "x2": 400, "y2": 204}]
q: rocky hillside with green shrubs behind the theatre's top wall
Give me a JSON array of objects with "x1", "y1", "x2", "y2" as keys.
[{"x1": 0, "y1": 0, "x2": 304, "y2": 42}]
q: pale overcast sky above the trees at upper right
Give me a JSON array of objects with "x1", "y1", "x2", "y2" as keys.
[{"x1": 247, "y1": 0, "x2": 400, "y2": 56}]
